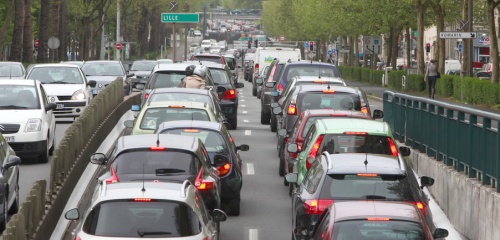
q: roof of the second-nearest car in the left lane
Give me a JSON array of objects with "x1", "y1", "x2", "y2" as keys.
[{"x1": 116, "y1": 134, "x2": 199, "y2": 152}]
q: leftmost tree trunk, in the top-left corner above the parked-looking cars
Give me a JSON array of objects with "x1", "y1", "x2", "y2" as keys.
[{"x1": 9, "y1": 0, "x2": 24, "y2": 62}]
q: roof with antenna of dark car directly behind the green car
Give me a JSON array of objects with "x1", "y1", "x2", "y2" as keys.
[{"x1": 325, "y1": 153, "x2": 406, "y2": 175}]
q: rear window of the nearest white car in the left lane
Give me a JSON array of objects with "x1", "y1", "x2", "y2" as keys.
[{"x1": 82, "y1": 199, "x2": 202, "y2": 238}]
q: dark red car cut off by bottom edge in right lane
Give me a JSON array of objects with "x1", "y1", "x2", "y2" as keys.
[{"x1": 311, "y1": 201, "x2": 448, "y2": 240}]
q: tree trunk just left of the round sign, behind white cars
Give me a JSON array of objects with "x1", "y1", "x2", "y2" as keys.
[{"x1": 37, "y1": 0, "x2": 50, "y2": 63}]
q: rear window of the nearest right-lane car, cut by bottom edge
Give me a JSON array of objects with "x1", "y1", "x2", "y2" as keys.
[{"x1": 331, "y1": 216, "x2": 426, "y2": 240}]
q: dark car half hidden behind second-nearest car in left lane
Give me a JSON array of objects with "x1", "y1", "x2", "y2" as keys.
[{"x1": 157, "y1": 121, "x2": 249, "y2": 215}]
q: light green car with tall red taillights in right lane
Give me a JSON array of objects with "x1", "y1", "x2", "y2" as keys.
[{"x1": 287, "y1": 118, "x2": 410, "y2": 184}]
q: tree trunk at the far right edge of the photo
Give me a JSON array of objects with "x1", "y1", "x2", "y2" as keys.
[{"x1": 487, "y1": 0, "x2": 500, "y2": 83}]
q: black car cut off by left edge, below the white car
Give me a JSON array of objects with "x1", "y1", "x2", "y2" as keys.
[{"x1": 0, "y1": 133, "x2": 21, "y2": 232}]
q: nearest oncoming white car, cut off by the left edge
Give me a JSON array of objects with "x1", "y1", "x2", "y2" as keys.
[{"x1": 0, "y1": 78, "x2": 56, "y2": 163}]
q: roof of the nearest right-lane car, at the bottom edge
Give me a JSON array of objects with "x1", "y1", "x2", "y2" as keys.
[{"x1": 329, "y1": 201, "x2": 422, "y2": 222}]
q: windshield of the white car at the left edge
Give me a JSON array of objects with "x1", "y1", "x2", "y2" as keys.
[{"x1": 0, "y1": 85, "x2": 40, "y2": 110}]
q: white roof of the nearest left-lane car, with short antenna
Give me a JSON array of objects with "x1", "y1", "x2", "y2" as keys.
[{"x1": 93, "y1": 181, "x2": 192, "y2": 205}]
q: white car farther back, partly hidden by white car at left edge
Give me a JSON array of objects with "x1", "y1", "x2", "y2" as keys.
[{"x1": 26, "y1": 64, "x2": 96, "y2": 118}]
